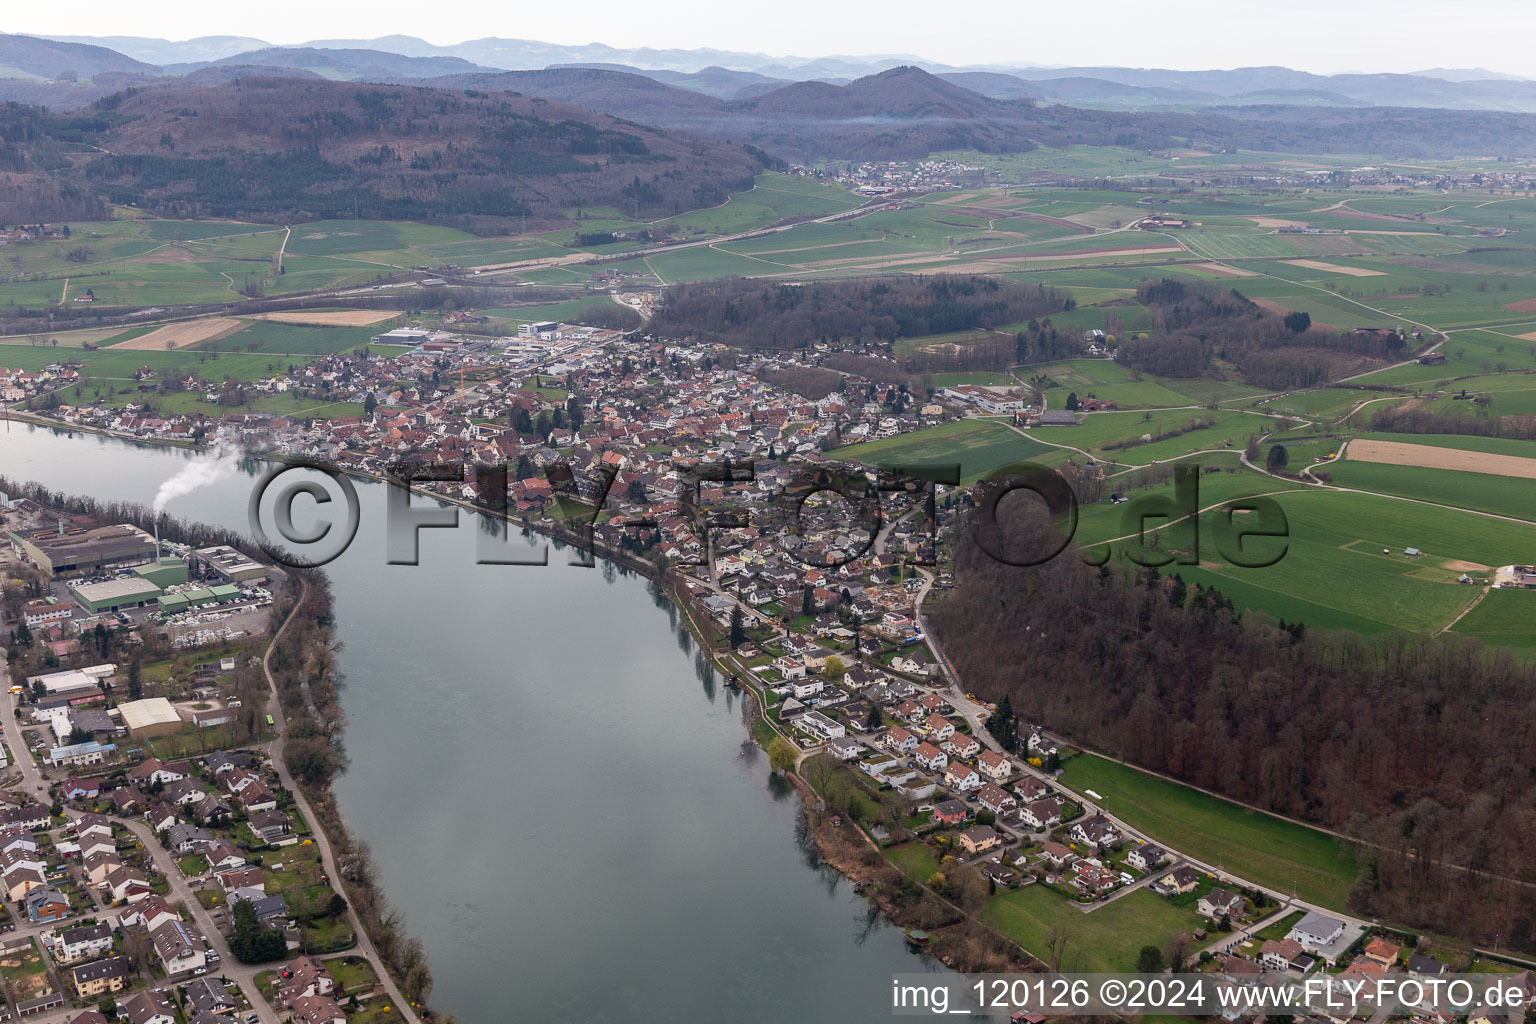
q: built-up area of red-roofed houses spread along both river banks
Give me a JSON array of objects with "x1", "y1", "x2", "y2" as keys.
[{"x1": 0, "y1": 307, "x2": 1536, "y2": 1024}]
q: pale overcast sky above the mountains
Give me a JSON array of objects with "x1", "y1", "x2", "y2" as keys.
[{"x1": 18, "y1": 0, "x2": 1536, "y2": 77}]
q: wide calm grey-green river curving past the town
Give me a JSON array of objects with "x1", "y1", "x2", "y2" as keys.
[{"x1": 0, "y1": 422, "x2": 946, "y2": 1024}]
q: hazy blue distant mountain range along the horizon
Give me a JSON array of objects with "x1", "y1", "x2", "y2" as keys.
[{"x1": 9, "y1": 35, "x2": 1536, "y2": 112}]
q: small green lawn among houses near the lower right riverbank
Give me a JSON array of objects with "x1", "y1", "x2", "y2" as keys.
[{"x1": 982, "y1": 884, "x2": 1203, "y2": 972}]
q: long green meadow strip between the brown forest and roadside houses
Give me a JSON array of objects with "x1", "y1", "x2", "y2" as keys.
[{"x1": 1061, "y1": 754, "x2": 1356, "y2": 907}]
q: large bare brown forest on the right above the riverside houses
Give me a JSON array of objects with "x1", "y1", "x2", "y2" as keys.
[{"x1": 928, "y1": 500, "x2": 1536, "y2": 952}]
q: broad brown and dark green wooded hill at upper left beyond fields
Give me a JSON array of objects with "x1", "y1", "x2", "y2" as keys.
[{"x1": 0, "y1": 78, "x2": 762, "y2": 229}]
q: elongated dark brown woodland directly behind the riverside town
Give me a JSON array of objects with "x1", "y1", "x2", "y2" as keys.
[{"x1": 651, "y1": 273, "x2": 1066, "y2": 350}]
